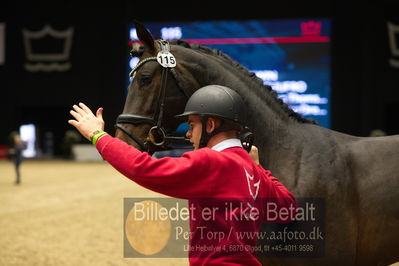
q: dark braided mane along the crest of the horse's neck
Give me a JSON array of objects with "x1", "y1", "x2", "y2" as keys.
[{"x1": 130, "y1": 39, "x2": 317, "y2": 124}]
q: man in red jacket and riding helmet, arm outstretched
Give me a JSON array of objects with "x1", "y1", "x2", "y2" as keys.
[{"x1": 69, "y1": 85, "x2": 296, "y2": 265}]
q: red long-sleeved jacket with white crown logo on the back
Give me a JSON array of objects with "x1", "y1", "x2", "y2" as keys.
[{"x1": 96, "y1": 135, "x2": 296, "y2": 265}]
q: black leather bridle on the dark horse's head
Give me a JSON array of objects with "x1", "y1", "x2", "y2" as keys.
[{"x1": 115, "y1": 40, "x2": 189, "y2": 151}]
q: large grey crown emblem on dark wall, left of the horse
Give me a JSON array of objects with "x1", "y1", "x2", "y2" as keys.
[{"x1": 22, "y1": 24, "x2": 74, "y2": 72}]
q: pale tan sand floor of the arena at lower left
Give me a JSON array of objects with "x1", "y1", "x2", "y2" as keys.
[{"x1": 0, "y1": 160, "x2": 188, "y2": 266}]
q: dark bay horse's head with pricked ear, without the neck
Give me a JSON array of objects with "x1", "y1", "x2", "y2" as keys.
[{"x1": 115, "y1": 22, "x2": 198, "y2": 153}]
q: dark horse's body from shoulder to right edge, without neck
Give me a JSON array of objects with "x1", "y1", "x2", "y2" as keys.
[{"x1": 262, "y1": 125, "x2": 399, "y2": 265}]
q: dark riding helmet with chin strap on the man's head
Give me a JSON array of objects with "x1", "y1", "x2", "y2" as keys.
[{"x1": 176, "y1": 85, "x2": 252, "y2": 148}]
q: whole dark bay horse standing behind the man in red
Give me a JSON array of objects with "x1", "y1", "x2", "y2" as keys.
[{"x1": 116, "y1": 24, "x2": 399, "y2": 266}]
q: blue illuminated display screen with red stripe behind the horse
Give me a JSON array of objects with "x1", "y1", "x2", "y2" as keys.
[{"x1": 128, "y1": 19, "x2": 331, "y2": 128}]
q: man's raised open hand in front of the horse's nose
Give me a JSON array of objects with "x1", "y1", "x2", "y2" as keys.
[{"x1": 68, "y1": 103, "x2": 104, "y2": 140}]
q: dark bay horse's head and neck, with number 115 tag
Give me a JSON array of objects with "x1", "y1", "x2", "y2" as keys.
[{"x1": 116, "y1": 22, "x2": 308, "y2": 153}]
